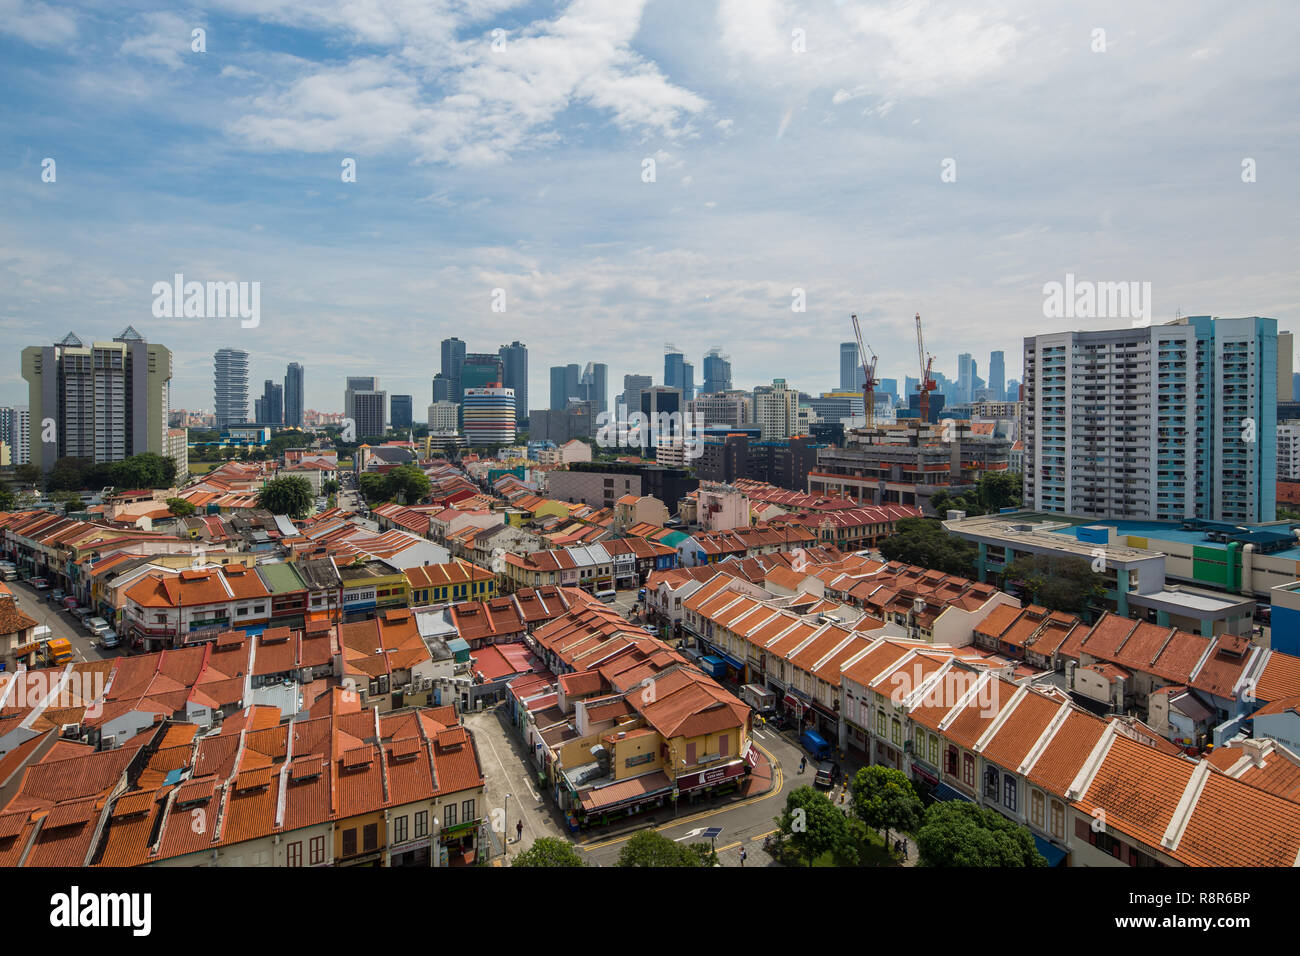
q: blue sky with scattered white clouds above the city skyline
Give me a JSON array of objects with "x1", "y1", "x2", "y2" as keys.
[{"x1": 0, "y1": 0, "x2": 1300, "y2": 418}]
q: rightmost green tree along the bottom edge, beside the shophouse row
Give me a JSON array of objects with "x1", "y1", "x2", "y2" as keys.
[{"x1": 917, "y1": 800, "x2": 1048, "y2": 866}]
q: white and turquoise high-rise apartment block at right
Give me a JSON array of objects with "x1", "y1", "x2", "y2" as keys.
[{"x1": 1024, "y1": 316, "x2": 1278, "y2": 523}]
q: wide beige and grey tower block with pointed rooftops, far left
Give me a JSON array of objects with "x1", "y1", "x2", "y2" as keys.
[{"x1": 17, "y1": 326, "x2": 172, "y2": 471}]
